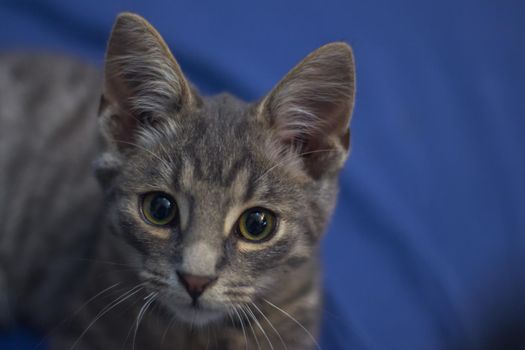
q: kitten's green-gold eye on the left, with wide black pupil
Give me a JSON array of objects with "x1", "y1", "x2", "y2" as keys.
[{"x1": 142, "y1": 192, "x2": 178, "y2": 226}]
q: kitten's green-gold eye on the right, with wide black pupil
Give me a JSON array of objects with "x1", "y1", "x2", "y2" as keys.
[{"x1": 237, "y1": 208, "x2": 276, "y2": 242}]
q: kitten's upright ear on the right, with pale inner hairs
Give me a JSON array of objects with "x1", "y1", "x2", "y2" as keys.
[{"x1": 258, "y1": 43, "x2": 355, "y2": 178}]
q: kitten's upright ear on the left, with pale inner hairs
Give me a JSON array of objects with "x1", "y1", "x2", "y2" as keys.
[{"x1": 100, "y1": 13, "x2": 195, "y2": 147}]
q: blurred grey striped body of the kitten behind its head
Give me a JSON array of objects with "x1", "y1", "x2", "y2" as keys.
[{"x1": 0, "y1": 54, "x2": 102, "y2": 324}]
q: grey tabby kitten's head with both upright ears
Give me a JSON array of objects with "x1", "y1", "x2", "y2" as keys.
[{"x1": 97, "y1": 13, "x2": 355, "y2": 324}]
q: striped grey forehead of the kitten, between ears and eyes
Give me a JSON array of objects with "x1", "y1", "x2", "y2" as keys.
[{"x1": 125, "y1": 94, "x2": 304, "y2": 194}]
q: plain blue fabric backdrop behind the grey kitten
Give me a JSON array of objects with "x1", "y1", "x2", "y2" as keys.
[{"x1": 0, "y1": 0, "x2": 525, "y2": 350}]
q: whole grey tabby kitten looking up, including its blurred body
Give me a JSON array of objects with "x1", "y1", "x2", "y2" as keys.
[{"x1": 0, "y1": 14, "x2": 355, "y2": 350}]
